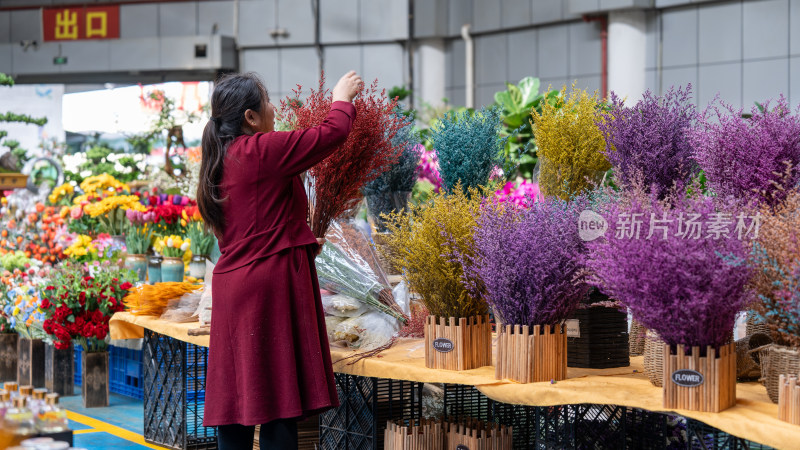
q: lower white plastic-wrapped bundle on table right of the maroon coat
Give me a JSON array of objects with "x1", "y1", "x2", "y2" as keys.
[{"x1": 326, "y1": 311, "x2": 400, "y2": 351}]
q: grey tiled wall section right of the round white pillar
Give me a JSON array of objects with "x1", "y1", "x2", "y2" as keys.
[{"x1": 647, "y1": 0, "x2": 800, "y2": 109}]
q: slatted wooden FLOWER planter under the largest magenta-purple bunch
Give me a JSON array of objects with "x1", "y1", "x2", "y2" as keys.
[{"x1": 663, "y1": 344, "x2": 736, "y2": 412}]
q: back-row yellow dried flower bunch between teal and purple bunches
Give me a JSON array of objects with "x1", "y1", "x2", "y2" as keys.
[{"x1": 532, "y1": 85, "x2": 611, "y2": 200}]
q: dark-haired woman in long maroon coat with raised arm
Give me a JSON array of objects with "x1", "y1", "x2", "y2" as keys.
[{"x1": 197, "y1": 72, "x2": 362, "y2": 450}]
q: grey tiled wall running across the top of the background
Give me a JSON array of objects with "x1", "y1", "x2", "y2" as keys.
[{"x1": 0, "y1": 0, "x2": 800, "y2": 107}]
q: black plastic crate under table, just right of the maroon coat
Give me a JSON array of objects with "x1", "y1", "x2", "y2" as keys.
[{"x1": 319, "y1": 373, "x2": 422, "y2": 450}]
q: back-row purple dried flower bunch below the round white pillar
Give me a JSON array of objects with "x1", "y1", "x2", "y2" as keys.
[{"x1": 597, "y1": 84, "x2": 697, "y2": 198}]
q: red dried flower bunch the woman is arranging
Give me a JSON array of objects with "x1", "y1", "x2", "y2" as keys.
[{"x1": 280, "y1": 75, "x2": 403, "y2": 237}]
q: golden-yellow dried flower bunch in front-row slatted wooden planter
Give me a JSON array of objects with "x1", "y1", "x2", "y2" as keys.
[{"x1": 381, "y1": 183, "x2": 488, "y2": 318}]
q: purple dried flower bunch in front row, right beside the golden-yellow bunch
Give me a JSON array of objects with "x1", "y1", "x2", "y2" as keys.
[{"x1": 465, "y1": 197, "x2": 589, "y2": 326}]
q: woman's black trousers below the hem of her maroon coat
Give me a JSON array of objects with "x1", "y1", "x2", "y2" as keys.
[{"x1": 217, "y1": 419, "x2": 297, "y2": 450}]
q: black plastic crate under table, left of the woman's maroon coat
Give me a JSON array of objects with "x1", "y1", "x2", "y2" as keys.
[{"x1": 142, "y1": 329, "x2": 217, "y2": 450}]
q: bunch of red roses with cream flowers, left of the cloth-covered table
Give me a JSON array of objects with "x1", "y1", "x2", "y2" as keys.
[{"x1": 39, "y1": 263, "x2": 134, "y2": 352}]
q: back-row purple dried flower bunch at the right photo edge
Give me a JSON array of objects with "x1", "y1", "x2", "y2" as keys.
[{"x1": 687, "y1": 96, "x2": 800, "y2": 205}]
